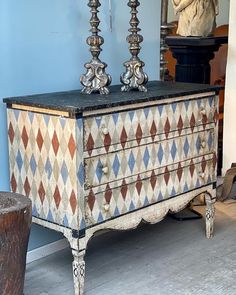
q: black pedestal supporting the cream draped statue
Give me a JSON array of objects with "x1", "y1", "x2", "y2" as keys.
[{"x1": 166, "y1": 36, "x2": 228, "y2": 84}]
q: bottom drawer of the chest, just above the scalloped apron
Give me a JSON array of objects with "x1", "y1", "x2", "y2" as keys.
[{"x1": 86, "y1": 157, "x2": 216, "y2": 226}]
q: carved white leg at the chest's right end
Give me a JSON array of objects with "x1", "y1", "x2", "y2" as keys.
[{"x1": 205, "y1": 193, "x2": 215, "y2": 239}]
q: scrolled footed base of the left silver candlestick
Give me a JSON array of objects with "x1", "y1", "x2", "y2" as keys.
[{"x1": 80, "y1": 58, "x2": 111, "y2": 94}]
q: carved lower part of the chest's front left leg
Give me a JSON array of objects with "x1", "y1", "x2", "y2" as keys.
[{"x1": 72, "y1": 250, "x2": 85, "y2": 295}]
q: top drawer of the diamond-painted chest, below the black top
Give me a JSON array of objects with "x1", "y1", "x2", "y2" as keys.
[{"x1": 84, "y1": 96, "x2": 217, "y2": 155}]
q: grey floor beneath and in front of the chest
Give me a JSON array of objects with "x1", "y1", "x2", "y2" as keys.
[{"x1": 25, "y1": 202, "x2": 236, "y2": 295}]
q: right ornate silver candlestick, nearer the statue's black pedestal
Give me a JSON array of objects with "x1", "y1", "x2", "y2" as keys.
[{"x1": 120, "y1": 0, "x2": 148, "y2": 91}]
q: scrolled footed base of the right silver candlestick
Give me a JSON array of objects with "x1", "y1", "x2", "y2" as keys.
[{"x1": 120, "y1": 58, "x2": 148, "y2": 92}]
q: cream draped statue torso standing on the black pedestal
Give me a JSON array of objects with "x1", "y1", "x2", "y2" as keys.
[{"x1": 172, "y1": 0, "x2": 219, "y2": 37}]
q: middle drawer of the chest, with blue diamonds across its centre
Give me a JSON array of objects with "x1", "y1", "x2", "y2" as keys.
[{"x1": 85, "y1": 129, "x2": 215, "y2": 189}]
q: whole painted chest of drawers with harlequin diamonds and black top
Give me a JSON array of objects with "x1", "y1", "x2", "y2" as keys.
[{"x1": 4, "y1": 82, "x2": 218, "y2": 295}]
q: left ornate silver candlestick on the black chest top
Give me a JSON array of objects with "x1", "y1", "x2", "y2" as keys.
[{"x1": 80, "y1": 0, "x2": 111, "y2": 94}]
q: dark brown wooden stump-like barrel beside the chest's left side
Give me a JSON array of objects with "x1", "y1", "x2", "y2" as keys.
[{"x1": 0, "y1": 192, "x2": 32, "y2": 295}]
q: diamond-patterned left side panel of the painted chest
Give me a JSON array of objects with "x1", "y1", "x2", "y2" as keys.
[{"x1": 8, "y1": 109, "x2": 83, "y2": 229}]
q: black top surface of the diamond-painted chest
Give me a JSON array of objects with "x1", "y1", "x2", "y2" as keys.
[{"x1": 3, "y1": 81, "x2": 222, "y2": 114}]
